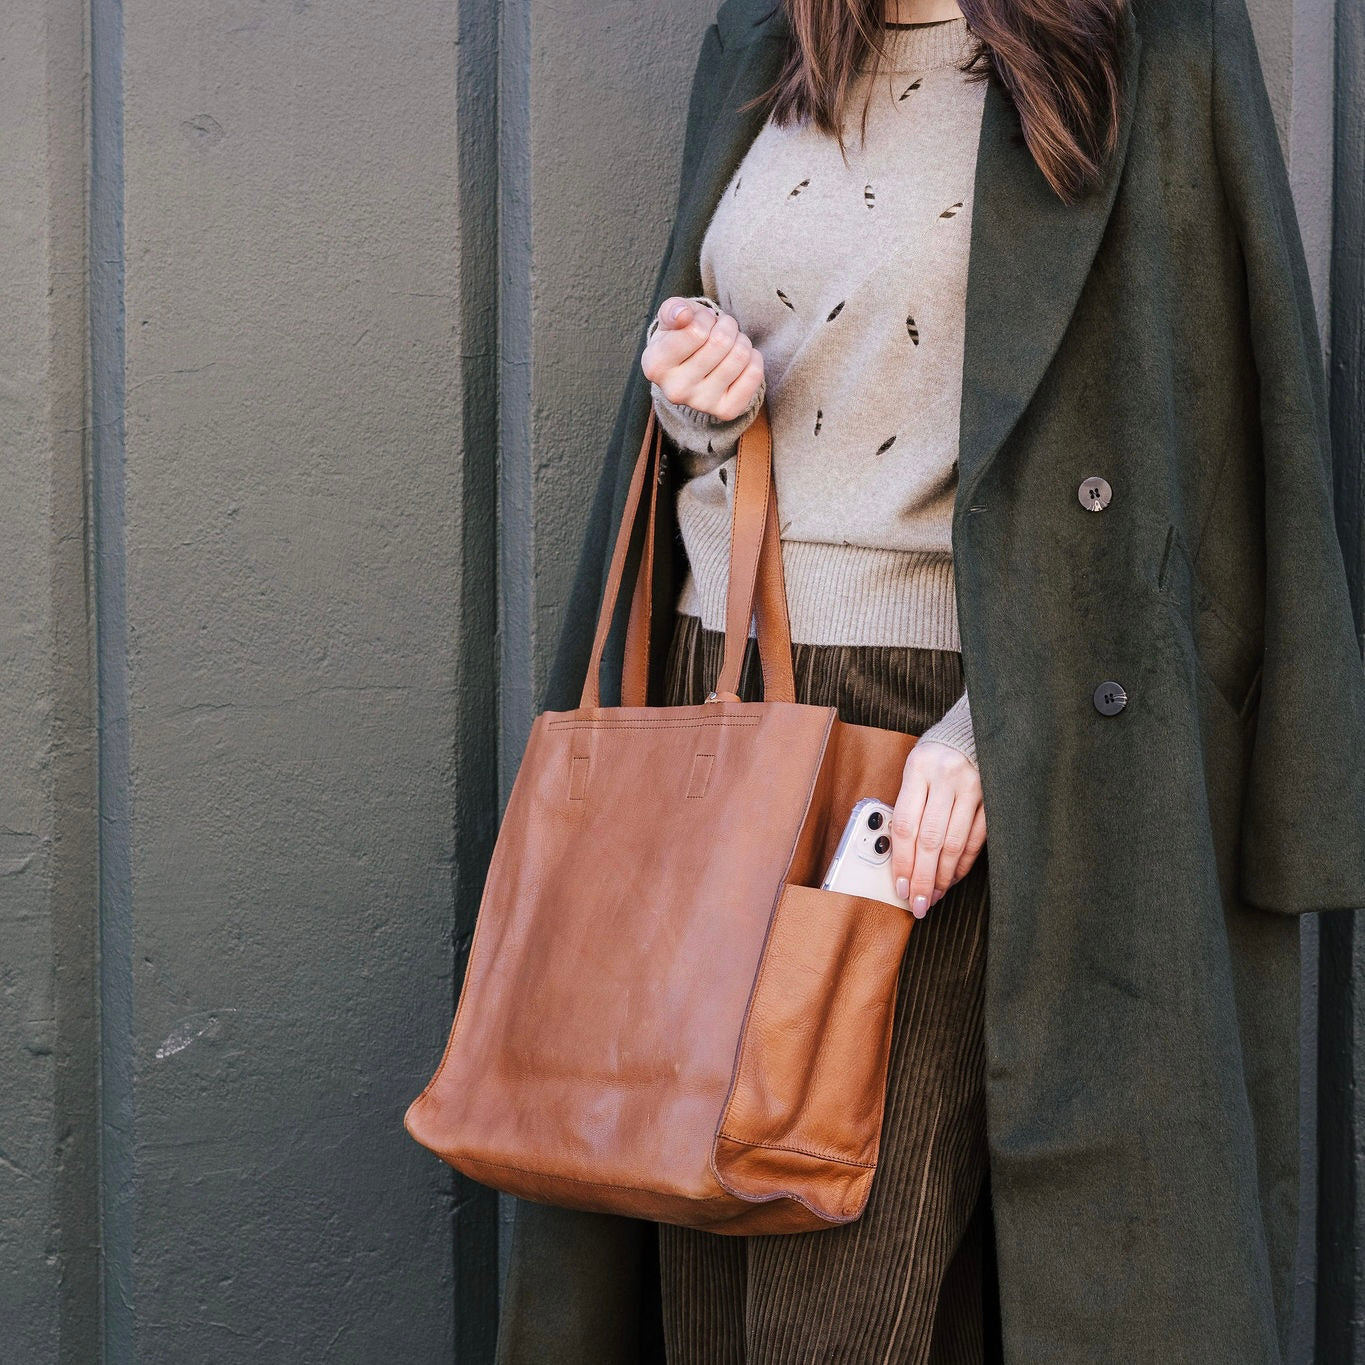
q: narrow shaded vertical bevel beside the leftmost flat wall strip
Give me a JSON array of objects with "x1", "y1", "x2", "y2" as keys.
[{"x1": 45, "y1": 0, "x2": 101, "y2": 1365}]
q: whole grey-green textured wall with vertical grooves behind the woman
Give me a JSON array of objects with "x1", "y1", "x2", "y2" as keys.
[{"x1": 0, "y1": 0, "x2": 1358, "y2": 1365}]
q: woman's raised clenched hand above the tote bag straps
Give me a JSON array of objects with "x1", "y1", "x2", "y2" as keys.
[{"x1": 640, "y1": 296, "x2": 763, "y2": 422}]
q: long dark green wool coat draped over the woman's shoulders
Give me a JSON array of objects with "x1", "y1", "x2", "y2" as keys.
[{"x1": 500, "y1": 0, "x2": 1365, "y2": 1365}]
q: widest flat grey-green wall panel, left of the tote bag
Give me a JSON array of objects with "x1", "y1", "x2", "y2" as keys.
[{"x1": 114, "y1": 0, "x2": 464, "y2": 1362}]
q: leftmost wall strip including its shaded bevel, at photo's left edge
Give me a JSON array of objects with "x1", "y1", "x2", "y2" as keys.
[{"x1": 0, "y1": 0, "x2": 97, "y2": 1362}]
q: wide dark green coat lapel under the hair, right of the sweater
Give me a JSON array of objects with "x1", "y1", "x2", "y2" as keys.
[{"x1": 957, "y1": 4, "x2": 1141, "y2": 509}]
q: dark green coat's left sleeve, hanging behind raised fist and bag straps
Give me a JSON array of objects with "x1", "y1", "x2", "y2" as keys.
[{"x1": 541, "y1": 23, "x2": 723, "y2": 711}]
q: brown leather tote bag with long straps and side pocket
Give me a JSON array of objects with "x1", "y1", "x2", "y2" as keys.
[{"x1": 405, "y1": 405, "x2": 917, "y2": 1234}]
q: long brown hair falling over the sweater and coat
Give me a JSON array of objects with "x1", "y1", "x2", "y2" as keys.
[{"x1": 745, "y1": 0, "x2": 1126, "y2": 202}]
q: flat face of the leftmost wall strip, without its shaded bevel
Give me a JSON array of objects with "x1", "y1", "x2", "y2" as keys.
[{"x1": 0, "y1": 4, "x2": 57, "y2": 1360}]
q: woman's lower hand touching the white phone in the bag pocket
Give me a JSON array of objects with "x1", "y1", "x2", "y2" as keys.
[{"x1": 891, "y1": 740, "x2": 986, "y2": 919}]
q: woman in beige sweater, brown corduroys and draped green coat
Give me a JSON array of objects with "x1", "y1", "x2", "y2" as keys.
[{"x1": 500, "y1": 0, "x2": 1365, "y2": 1362}]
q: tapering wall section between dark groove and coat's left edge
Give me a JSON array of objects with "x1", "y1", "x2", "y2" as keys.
[{"x1": 505, "y1": 0, "x2": 717, "y2": 737}]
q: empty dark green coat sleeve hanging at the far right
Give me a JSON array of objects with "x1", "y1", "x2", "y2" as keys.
[{"x1": 1211, "y1": 0, "x2": 1365, "y2": 913}]
